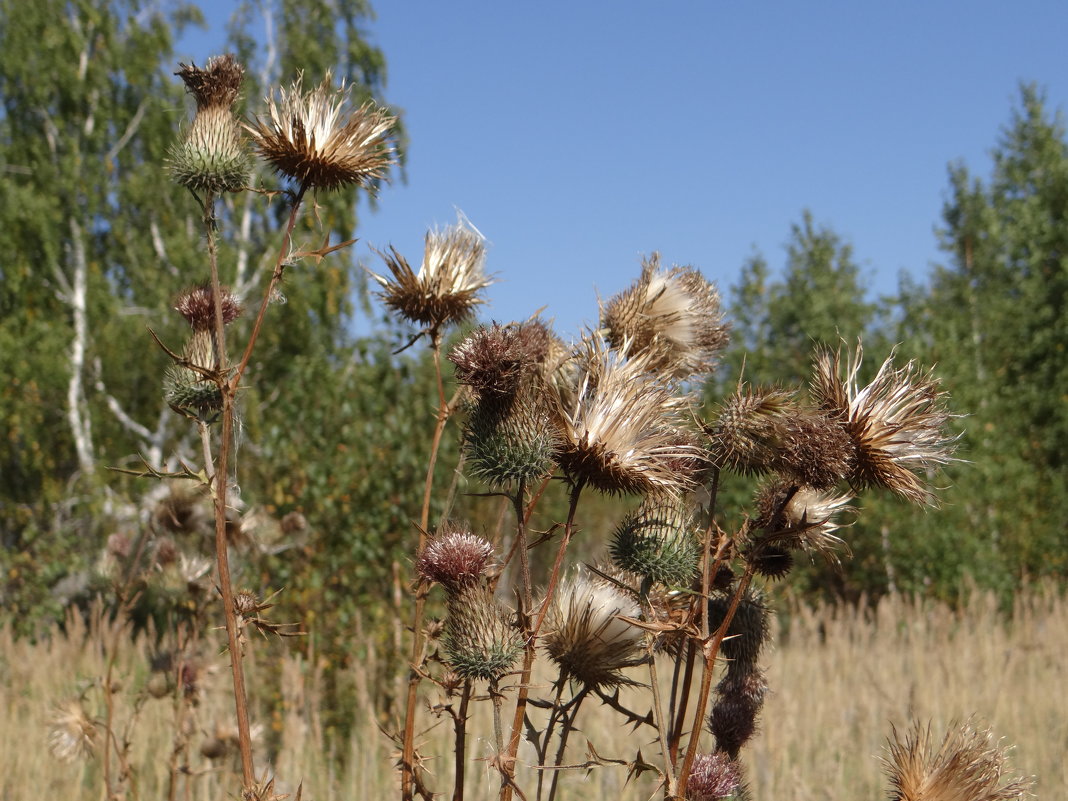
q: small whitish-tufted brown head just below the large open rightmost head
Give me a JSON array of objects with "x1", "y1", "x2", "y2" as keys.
[{"x1": 754, "y1": 480, "x2": 854, "y2": 564}]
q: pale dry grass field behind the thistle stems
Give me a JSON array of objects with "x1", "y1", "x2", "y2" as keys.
[{"x1": 0, "y1": 591, "x2": 1068, "y2": 801}]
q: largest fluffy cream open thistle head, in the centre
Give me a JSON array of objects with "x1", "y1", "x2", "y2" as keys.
[{"x1": 556, "y1": 337, "x2": 703, "y2": 493}]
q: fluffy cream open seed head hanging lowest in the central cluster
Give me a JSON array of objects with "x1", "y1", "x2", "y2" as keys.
[{"x1": 544, "y1": 572, "x2": 644, "y2": 689}]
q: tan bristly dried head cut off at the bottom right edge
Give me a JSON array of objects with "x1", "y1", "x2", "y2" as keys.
[{"x1": 883, "y1": 721, "x2": 1032, "y2": 801}]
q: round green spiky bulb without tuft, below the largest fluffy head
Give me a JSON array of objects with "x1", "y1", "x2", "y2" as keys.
[{"x1": 611, "y1": 501, "x2": 701, "y2": 586}]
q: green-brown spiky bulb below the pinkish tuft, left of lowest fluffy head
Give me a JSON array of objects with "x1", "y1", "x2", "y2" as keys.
[{"x1": 441, "y1": 584, "x2": 523, "y2": 680}]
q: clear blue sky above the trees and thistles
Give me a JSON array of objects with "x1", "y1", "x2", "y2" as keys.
[{"x1": 180, "y1": 0, "x2": 1068, "y2": 333}]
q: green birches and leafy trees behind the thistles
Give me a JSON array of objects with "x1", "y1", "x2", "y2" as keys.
[{"x1": 0, "y1": 0, "x2": 1068, "y2": 653}]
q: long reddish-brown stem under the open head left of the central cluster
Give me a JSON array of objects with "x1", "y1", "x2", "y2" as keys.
[{"x1": 401, "y1": 332, "x2": 452, "y2": 801}]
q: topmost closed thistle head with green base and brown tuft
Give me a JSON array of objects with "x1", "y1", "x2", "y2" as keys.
[{"x1": 170, "y1": 53, "x2": 251, "y2": 193}]
